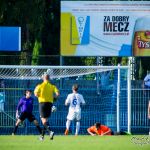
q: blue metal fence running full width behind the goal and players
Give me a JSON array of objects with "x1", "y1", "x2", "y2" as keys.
[{"x1": 0, "y1": 80, "x2": 150, "y2": 134}]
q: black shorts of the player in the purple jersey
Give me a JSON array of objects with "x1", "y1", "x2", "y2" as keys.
[{"x1": 19, "y1": 112, "x2": 36, "y2": 122}]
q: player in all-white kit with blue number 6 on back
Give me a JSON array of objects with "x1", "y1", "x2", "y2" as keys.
[{"x1": 65, "y1": 84, "x2": 85, "y2": 135}]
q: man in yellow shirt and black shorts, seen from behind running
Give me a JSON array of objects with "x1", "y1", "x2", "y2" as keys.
[{"x1": 34, "y1": 74, "x2": 59, "y2": 140}]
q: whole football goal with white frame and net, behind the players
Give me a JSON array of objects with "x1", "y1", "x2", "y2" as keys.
[{"x1": 0, "y1": 65, "x2": 131, "y2": 134}]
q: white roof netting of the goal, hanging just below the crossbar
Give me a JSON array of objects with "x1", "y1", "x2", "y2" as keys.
[{"x1": 0, "y1": 66, "x2": 122, "y2": 80}]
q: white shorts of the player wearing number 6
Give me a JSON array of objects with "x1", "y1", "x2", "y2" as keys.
[{"x1": 67, "y1": 111, "x2": 81, "y2": 121}]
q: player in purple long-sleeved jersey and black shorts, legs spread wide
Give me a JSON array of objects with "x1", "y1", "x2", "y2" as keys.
[{"x1": 12, "y1": 90, "x2": 42, "y2": 135}]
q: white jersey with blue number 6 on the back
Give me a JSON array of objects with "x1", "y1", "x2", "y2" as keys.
[{"x1": 65, "y1": 93, "x2": 85, "y2": 111}]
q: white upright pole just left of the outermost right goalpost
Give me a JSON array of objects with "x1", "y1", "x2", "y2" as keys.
[{"x1": 117, "y1": 64, "x2": 120, "y2": 132}]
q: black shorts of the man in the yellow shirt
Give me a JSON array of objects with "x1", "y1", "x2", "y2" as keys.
[{"x1": 39, "y1": 102, "x2": 52, "y2": 118}]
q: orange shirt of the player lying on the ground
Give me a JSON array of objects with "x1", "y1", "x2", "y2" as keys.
[{"x1": 88, "y1": 125, "x2": 111, "y2": 135}]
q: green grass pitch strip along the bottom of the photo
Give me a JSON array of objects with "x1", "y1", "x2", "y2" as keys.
[{"x1": 0, "y1": 135, "x2": 150, "y2": 150}]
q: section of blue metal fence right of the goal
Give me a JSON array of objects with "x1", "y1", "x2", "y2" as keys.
[{"x1": 131, "y1": 81, "x2": 150, "y2": 133}]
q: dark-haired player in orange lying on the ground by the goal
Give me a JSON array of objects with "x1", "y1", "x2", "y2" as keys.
[{"x1": 87, "y1": 122, "x2": 112, "y2": 136}]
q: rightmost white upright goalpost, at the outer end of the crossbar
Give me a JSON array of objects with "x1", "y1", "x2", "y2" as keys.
[{"x1": 128, "y1": 67, "x2": 131, "y2": 133}]
